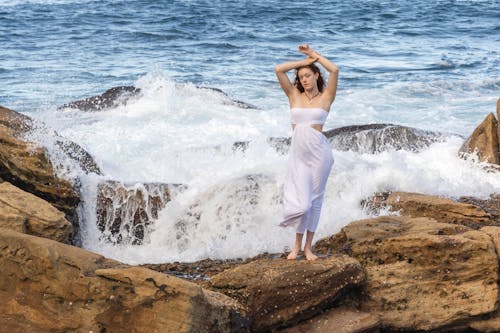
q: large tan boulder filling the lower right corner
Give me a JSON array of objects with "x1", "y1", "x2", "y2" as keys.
[{"x1": 316, "y1": 216, "x2": 498, "y2": 330}]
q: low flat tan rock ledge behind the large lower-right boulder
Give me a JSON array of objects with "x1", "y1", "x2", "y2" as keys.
[{"x1": 365, "y1": 192, "x2": 496, "y2": 229}]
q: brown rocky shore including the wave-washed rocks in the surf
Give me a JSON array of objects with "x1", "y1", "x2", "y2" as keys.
[{"x1": 0, "y1": 94, "x2": 500, "y2": 333}]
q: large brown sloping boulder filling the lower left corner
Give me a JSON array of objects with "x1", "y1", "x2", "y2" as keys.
[{"x1": 0, "y1": 229, "x2": 249, "y2": 333}]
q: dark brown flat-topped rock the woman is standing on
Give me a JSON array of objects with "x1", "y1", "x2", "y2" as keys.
[{"x1": 210, "y1": 255, "x2": 365, "y2": 331}]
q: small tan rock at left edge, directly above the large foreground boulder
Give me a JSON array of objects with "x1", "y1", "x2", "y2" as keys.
[{"x1": 0, "y1": 182, "x2": 73, "y2": 243}]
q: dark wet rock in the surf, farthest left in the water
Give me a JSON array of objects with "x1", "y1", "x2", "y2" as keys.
[{"x1": 59, "y1": 86, "x2": 141, "y2": 111}]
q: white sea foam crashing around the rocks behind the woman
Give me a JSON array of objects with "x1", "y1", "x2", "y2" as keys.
[{"x1": 32, "y1": 75, "x2": 500, "y2": 264}]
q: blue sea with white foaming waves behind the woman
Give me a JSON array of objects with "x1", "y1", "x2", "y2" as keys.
[{"x1": 0, "y1": 0, "x2": 500, "y2": 263}]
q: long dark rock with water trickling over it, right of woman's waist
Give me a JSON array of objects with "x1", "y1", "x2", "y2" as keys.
[{"x1": 324, "y1": 124, "x2": 445, "y2": 154}]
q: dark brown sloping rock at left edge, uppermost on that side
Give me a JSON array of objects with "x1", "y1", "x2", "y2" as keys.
[{"x1": 0, "y1": 107, "x2": 80, "y2": 217}]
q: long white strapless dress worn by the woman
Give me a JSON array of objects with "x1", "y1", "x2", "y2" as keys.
[{"x1": 280, "y1": 108, "x2": 334, "y2": 234}]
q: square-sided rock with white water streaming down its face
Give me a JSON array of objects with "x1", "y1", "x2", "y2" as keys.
[{"x1": 96, "y1": 181, "x2": 184, "y2": 244}]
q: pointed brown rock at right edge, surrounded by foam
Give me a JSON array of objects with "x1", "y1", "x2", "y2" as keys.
[{"x1": 459, "y1": 113, "x2": 500, "y2": 164}]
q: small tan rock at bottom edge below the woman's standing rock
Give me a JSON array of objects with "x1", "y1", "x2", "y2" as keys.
[{"x1": 279, "y1": 307, "x2": 380, "y2": 333}]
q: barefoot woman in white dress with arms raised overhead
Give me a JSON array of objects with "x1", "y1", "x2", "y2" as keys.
[{"x1": 275, "y1": 44, "x2": 339, "y2": 260}]
